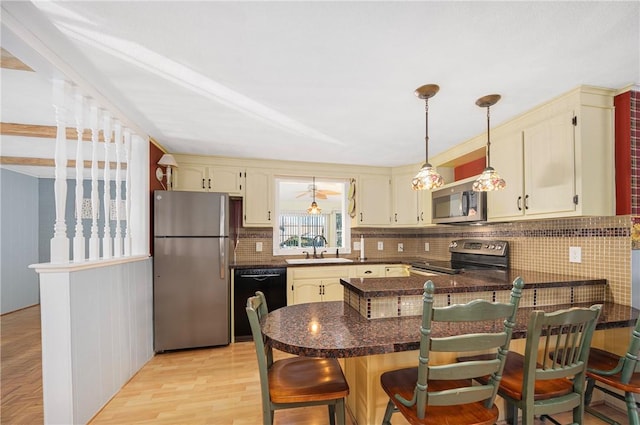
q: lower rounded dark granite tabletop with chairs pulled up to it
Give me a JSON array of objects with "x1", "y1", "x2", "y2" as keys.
[{"x1": 262, "y1": 301, "x2": 640, "y2": 357}]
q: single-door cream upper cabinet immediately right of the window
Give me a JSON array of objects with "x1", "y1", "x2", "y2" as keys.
[{"x1": 356, "y1": 175, "x2": 391, "y2": 226}]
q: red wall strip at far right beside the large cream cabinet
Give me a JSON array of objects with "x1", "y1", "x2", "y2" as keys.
[{"x1": 613, "y1": 91, "x2": 638, "y2": 215}]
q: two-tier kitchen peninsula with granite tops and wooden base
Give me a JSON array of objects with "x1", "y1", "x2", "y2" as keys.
[{"x1": 263, "y1": 270, "x2": 638, "y2": 424}]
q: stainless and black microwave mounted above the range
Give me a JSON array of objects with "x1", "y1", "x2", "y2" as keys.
[{"x1": 431, "y1": 181, "x2": 487, "y2": 224}]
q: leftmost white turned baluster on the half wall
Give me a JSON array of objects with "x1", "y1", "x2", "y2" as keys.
[{"x1": 50, "y1": 80, "x2": 69, "y2": 263}]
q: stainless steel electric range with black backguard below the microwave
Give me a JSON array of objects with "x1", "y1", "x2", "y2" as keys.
[{"x1": 411, "y1": 239, "x2": 509, "y2": 274}]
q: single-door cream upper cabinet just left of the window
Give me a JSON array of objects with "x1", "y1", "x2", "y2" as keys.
[{"x1": 242, "y1": 168, "x2": 275, "y2": 227}]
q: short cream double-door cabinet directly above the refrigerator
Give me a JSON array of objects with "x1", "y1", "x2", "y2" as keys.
[{"x1": 175, "y1": 163, "x2": 244, "y2": 196}]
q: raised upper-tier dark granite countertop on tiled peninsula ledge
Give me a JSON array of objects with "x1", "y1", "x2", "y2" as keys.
[{"x1": 340, "y1": 269, "x2": 607, "y2": 298}]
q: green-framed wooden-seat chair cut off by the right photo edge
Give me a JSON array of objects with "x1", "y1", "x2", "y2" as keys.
[{"x1": 585, "y1": 317, "x2": 640, "y2": 425}]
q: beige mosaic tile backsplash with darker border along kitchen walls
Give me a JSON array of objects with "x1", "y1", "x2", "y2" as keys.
[{"x1": 236, "y1": 215, "x2": 632, "y2": 305}]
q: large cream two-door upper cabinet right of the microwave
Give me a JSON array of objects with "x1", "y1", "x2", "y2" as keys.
[{"x1": 487, "y1": 85, "x2": 615, "y2": 221}]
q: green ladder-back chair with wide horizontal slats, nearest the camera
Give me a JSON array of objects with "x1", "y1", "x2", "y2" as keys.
[{"x1": 380, "y1": 278, "x2": 524, "y2": 425}]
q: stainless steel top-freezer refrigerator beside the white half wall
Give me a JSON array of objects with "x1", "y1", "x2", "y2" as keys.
[{"x1": 153, "y1": 190, "x2": 231, "y2": 352}]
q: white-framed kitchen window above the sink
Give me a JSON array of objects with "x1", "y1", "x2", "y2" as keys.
[{"x1": 273, "y1": 176, "x2": 350, "y2": 256}]
